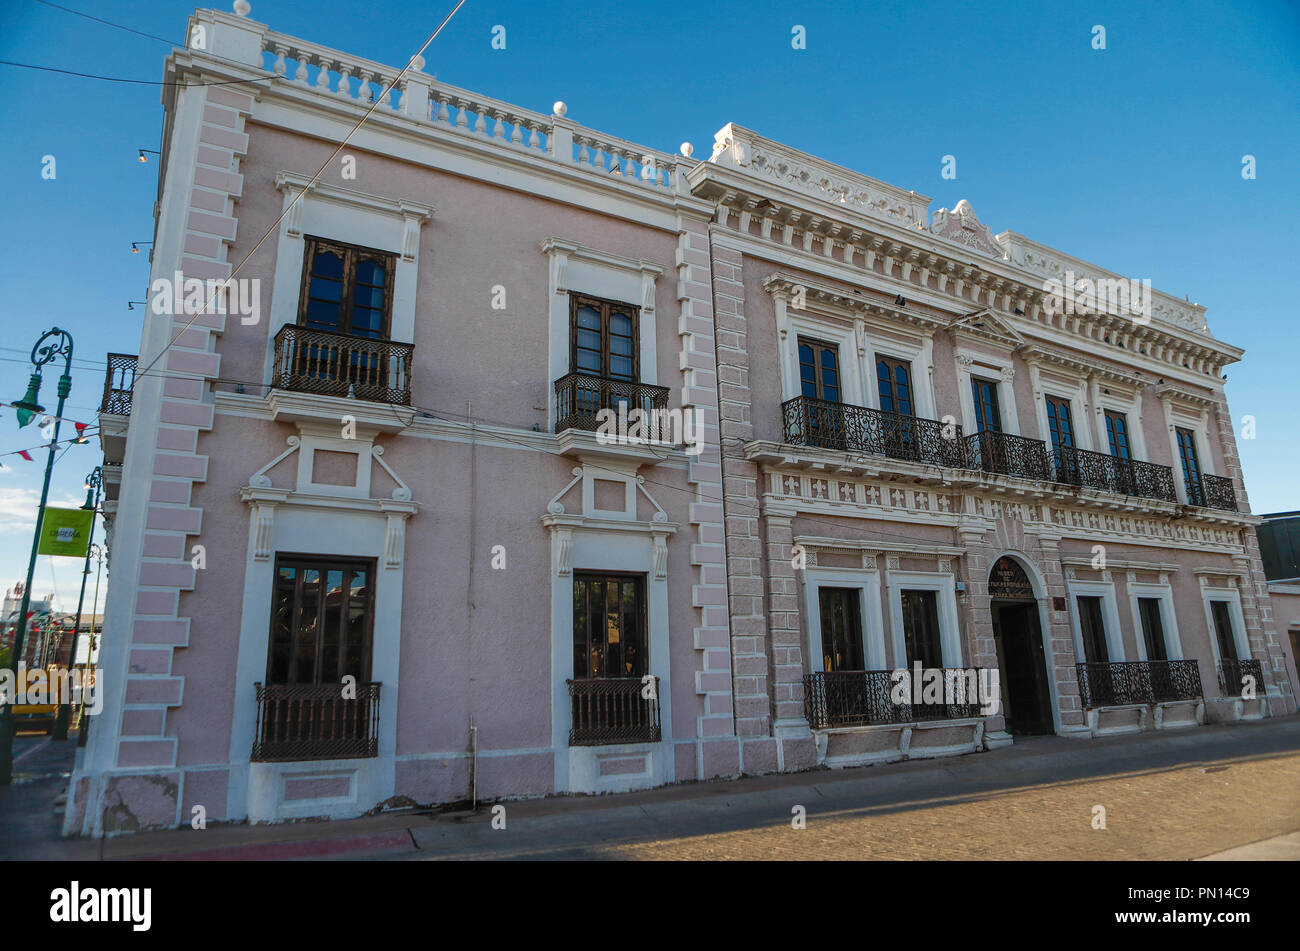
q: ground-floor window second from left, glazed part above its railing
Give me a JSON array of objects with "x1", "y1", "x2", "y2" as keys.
[{"x1": 573, "y1": 572, "x2": 650, "y2": 679}]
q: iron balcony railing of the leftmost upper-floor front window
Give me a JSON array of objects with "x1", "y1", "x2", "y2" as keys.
[{"x1": 270, "y1": 323, "x2": 415, "y2": 407}]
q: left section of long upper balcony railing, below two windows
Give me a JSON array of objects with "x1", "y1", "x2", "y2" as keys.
[{"x1": 781, "y1": 396, "x2": 966, "y2": 469}]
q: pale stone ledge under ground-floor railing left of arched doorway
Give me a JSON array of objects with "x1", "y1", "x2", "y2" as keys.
[{"x1": 813, "y1": 717, "x2": 982, "y2": 769}]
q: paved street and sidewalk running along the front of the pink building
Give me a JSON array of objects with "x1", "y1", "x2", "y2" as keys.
[{"x1": 0, "y1": 717, "x2": 1300, "y2": 860}]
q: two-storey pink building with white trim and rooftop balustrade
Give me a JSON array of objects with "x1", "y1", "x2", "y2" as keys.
[{"x1": 65, "y1": 3, "x2": 1295, "y2": 835}]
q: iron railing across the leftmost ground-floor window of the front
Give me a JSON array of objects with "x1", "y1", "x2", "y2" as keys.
[{"x1": 250, "y1": 683, "x2": 382, "y2": 763}]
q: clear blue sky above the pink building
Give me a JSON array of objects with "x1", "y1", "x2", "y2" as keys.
[{"x1": 0, "y1": 0, "x2": 1300, "y2": 609}]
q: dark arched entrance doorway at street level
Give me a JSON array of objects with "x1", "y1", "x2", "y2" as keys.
[{"x1": 988, "y1": 555, "x2": 1053, "y2": 735}]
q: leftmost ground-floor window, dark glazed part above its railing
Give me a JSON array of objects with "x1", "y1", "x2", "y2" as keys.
[{"x1": 267, "y1": 555, "x2": 374, "y2": 685}]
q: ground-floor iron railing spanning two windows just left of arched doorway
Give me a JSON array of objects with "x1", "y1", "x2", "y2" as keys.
[{"x1": 803, "y1": 668, "x2": 983, "y2": 730}]
